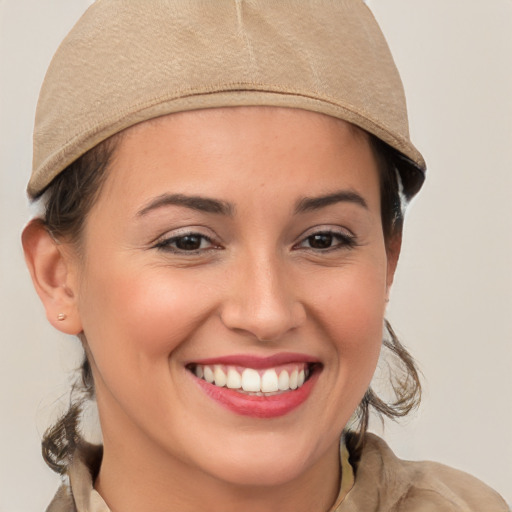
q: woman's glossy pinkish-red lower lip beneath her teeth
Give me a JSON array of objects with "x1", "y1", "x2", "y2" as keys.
[{"x1": 191, "y1": 371, "x2": 320, "y2": 418}]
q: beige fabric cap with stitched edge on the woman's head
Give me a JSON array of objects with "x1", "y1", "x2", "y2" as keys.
[{"x1": 28, "y1": 0, "x2": 425, "y2": 197}]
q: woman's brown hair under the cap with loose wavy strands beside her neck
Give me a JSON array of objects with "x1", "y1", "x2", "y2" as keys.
[{"x1": 37, "y1": 130, "x2": 421, "y2": 474}]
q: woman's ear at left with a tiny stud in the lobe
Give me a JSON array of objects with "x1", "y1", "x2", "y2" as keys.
[{"x1": 21, "y1": 219, "x2": 82, "y2": 334}]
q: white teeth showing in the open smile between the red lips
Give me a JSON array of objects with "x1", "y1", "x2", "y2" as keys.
[{"x1": 187, "y1": 362, "x2": 320, "y2": 396}]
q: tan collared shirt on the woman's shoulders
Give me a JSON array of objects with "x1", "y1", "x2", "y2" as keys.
[{"x1": 46, "y1": 434, "x2": 510, "y2": 512}]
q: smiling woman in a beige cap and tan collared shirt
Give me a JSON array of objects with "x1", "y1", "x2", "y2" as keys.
[{"x1": 19, "y1": 0, "x2": 507, "y2": 511}]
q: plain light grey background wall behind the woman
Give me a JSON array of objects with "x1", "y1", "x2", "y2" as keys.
[{"x1": 0, "y1": 0, "x2": 512, "y2": 512}]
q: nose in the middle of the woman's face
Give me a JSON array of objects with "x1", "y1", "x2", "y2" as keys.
[{"x1": 221, "y1": 251, "x2": 306, "y2": 341}]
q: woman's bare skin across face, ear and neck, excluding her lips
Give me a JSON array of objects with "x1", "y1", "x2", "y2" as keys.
[{"x1": 24, "y1": 107, "x2": 400, "y2": 512}]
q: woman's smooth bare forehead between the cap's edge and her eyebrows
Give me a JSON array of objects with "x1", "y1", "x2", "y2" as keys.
[{"x1": 95, "y1": 107, "x2": 379, "y2": 211}]
